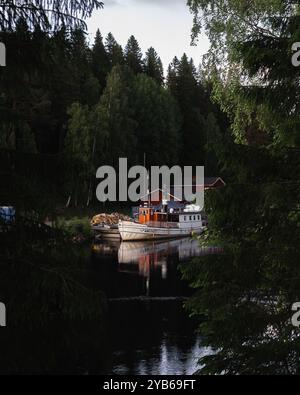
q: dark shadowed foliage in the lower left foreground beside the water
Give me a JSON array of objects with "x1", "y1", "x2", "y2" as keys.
[{"x1": 0, "y1": 217, "x2": 107, "y2": 374}]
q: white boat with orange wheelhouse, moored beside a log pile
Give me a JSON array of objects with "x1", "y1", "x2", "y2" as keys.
[{"x1": 119, "y1": 205, "x2": 205, "y2": 241}]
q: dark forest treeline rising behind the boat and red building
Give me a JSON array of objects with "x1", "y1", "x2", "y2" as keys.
[{"x1": 0, "y1": 20, "x2": 227, "y2": 205}]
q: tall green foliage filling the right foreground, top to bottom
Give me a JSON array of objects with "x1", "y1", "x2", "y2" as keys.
[{"x1": 183, "y1": 0, "x2": 300, "y2": 374}]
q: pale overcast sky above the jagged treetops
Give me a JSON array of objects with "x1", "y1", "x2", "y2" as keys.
[{"x1": 87, "y1": 0, "x2": 209, "y2": 74}]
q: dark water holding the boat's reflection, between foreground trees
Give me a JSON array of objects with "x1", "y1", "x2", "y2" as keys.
[{"x1": 92, "y1": 239, "x2": 215, "y2": 375}]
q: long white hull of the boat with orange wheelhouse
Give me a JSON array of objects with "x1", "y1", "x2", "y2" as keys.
[{"x1": 119, "y1": 221, "x2": 204, "y2": 241}]
